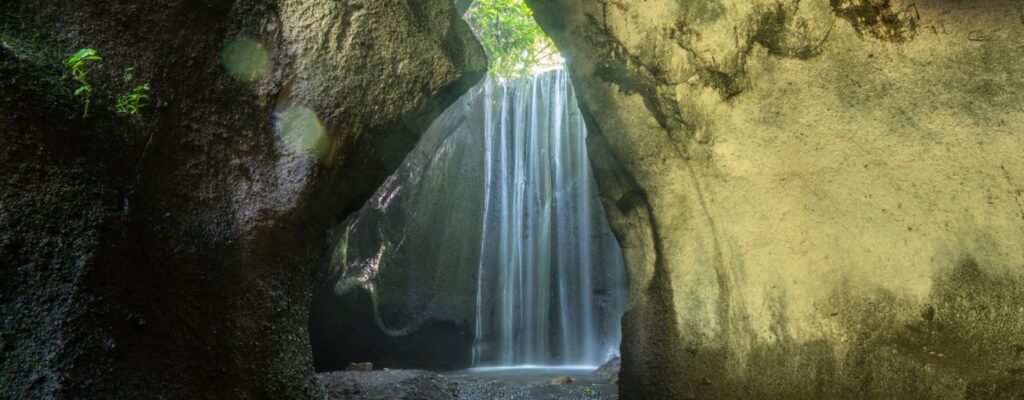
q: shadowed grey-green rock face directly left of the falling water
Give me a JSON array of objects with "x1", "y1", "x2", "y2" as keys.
[{"x1": 310, "y1": 77, "x2": 485, "y2": 371}]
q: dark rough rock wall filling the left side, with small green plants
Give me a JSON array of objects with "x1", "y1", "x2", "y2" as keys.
[{"x1": 0, "y1": 0, "x2": 485, "y2": 399}]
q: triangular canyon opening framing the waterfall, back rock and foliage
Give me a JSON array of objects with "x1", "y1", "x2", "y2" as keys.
[{"x1": 309, "y1": 0, "x2": 628, "y2": 388}]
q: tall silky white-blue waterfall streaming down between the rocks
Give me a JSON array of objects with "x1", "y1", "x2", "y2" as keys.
[{"x1": 473, "y1": 70, "x2": 625, "y2": 366}]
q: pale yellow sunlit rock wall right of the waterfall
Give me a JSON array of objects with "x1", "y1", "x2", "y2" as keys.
[{"x1": 529, "y1": 0, "x2": 1024, "y2": 398}]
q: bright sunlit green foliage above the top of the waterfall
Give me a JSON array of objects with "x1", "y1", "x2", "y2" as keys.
[{"x1": 468, "y1": 0, "x2": 558, "y2": 78}]
